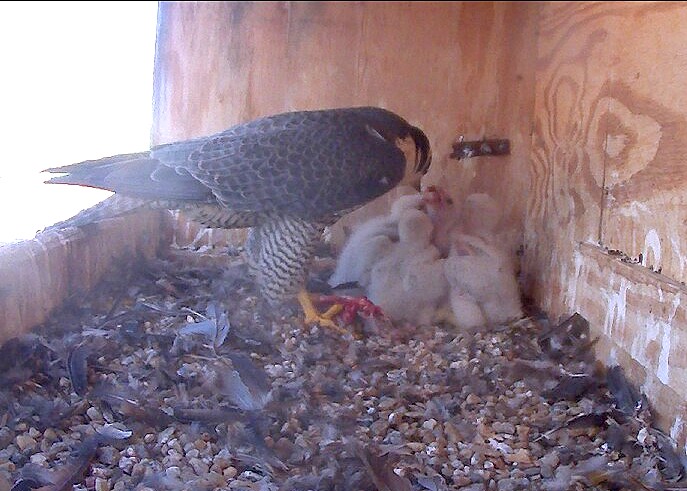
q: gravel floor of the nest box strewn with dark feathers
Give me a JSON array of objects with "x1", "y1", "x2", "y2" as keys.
[{"x1": 0, "y1": 250, "x2": 683, "y2": 491}]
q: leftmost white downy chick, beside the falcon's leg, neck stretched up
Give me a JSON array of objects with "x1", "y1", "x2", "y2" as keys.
[{"x1": 328, "y1": 192, "x2": 424, "y2": 288}]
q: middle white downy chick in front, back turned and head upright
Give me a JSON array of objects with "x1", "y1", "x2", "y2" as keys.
[{"x1": 368, "y1": 209, "x2": 448, "y2": 325}]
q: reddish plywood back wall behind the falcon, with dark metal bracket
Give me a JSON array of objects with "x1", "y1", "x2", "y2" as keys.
[{"x1": 153, "y1": 2, "x2": 538, "y2": 250}]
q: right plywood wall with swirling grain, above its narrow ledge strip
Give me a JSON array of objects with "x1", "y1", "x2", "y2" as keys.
[{"x1": 525, "y1": 2, "x2": 687, "y2": 314}]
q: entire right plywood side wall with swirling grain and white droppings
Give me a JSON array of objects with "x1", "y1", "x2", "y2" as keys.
[{"x1": 525, "y1": 2, "x2": 687, "y2": 444}]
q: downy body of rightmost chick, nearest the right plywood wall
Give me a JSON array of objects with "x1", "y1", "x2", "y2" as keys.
[{"x1": 444, "y1": 234, "x2": 523, "y2": 327}]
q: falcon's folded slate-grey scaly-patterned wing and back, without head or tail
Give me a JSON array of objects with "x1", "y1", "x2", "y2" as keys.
[{"x1": 151, "y1": 110, "x2": 405, "y2": 218}]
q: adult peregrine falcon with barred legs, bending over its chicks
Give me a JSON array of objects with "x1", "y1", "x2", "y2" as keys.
[{"x1": 47, "y1": 107, "x2": 431, "y2": 326}]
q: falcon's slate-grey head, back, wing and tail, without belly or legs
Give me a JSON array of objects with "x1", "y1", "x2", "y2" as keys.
[{"x1": 48, "y1": 107, "x2": 431, "y2": 220}]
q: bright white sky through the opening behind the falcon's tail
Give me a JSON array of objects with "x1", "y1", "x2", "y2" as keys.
[{"x1": 0, "y1": 1, "x2": 157, "y2": 244}]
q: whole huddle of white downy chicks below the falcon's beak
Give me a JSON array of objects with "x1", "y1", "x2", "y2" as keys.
[{"x1": 329, "y1": 186, "x2": 523, "y2": 329}]
